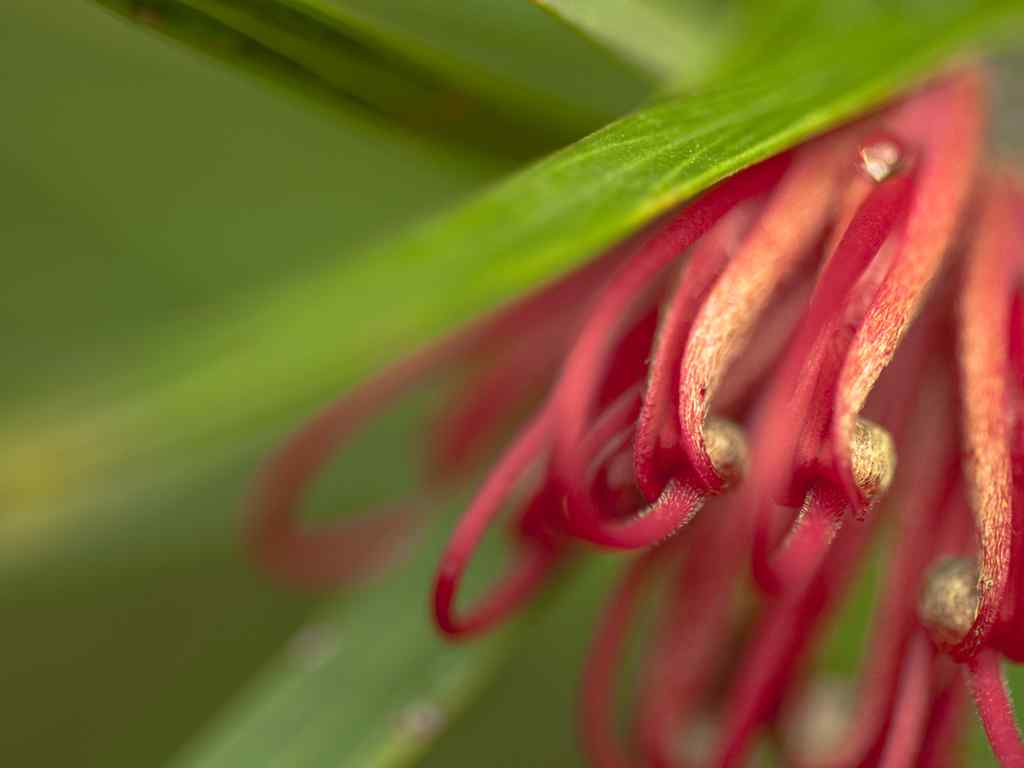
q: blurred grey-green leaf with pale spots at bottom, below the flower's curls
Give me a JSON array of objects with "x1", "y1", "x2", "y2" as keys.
[{"x1": 165, "y1": 505, "x2": 522, "y2": 768}]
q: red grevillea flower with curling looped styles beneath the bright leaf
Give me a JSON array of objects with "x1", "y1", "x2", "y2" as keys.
[{"x1": 245, "y1": 71, "x2": 1024, "y2": 768}]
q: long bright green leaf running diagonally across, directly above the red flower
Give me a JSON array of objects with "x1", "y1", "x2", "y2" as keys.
[{"x1": 6, "y1": 1, "x2": 1021, "y2": 565}]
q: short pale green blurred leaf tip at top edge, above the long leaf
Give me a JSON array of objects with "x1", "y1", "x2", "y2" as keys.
[{"x1": 532, "y1": 0, "x2": 737, "y2": 85}]
